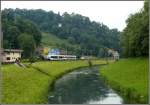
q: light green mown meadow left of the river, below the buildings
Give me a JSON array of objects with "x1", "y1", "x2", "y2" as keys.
[{"x1": 2, "y1": 60, "x2": 106, "y2": 104}]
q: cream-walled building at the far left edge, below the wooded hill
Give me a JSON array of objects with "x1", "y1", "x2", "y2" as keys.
[{"x1": 2, "y1": 49, "x2": 23, "y2": 63}]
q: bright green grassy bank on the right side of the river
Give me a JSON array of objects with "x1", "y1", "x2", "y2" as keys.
[{"x1": 100, "y1": 58, "x2": 148, "y2": 103}]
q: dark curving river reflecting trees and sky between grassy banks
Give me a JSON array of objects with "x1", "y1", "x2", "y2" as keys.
[{"x1": 48, "y1": 67, "x2": 123, "y2": 104}]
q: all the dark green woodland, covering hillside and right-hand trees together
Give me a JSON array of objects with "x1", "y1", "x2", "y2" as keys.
[{"x1": 2, "y1": 1, "x2": 149, "y2": 57}]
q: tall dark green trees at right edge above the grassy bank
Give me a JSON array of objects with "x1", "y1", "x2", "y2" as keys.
[{"x1": 121, "y1": 0, "x2": 149, "y2": 57}]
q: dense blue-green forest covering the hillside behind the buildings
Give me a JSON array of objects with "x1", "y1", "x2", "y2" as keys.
[{"x1": 2, "y1": 9, "x2": 120, "y2": 56}]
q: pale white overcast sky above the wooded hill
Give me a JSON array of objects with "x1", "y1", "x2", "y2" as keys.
[{"x1": 1, "y1": 1, "x2": 144, "y2": 31}]
